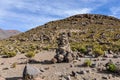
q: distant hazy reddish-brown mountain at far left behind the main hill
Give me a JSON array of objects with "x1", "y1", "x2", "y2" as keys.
[{"x1": 0, "y1": 29, "x2": 20, "y2": 39}]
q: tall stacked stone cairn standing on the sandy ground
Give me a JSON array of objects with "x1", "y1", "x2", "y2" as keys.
[{"x1": 51, "y1": 33, "x2": 74, "y2": 63}]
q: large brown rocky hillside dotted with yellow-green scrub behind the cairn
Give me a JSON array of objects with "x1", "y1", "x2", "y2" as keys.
[{"x1": 0, "y1": 14, "x2": 120, "y2": 54}]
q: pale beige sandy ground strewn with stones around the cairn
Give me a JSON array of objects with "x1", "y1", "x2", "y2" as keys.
[{"x1": 0, "y1": 51, "x2": 120, "y2": 80}]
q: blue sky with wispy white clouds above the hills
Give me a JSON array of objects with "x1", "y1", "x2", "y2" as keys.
[{"x1": 0, "y1": 0, "x2": 120, "y2": 32}]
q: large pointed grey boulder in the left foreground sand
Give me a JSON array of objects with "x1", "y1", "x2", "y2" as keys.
[{"x1": 23, "y1": 64, "x2": 40, "y2": 80}]
